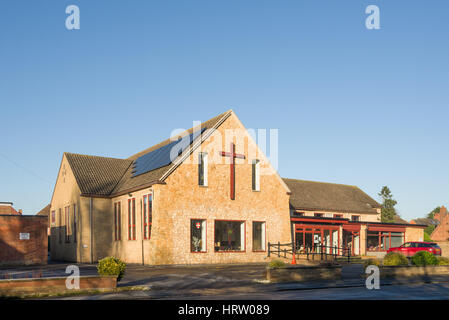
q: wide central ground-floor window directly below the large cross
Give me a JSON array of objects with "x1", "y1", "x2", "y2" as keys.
[{"x1": 215, "y1": 220, "x2": 245, "y2": 252}]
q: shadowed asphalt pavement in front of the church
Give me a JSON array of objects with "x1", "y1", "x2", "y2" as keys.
[{"x1": 4, "y1": 263, "x2": 449, "y2": 300}]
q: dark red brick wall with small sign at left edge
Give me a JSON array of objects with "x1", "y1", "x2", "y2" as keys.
[{"x1": 0, "y1": 215, "x2": 48, "y2": 265}]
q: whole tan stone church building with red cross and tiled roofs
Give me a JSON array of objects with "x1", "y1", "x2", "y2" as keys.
[{"x1": 49, "y1": 110, "x2": 423, "y2": 265}]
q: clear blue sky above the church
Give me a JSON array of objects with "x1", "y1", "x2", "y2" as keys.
[{"x1": 0, "y1": 0, "x2": 449, "y2": 220}]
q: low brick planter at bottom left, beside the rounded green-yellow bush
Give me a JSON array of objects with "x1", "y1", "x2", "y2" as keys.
[{"x1": 0, "y1": 276, "x2": 117, "y2": 295}]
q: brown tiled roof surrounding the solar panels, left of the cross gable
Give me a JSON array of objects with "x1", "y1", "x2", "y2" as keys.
[{"x1": 65, "y1": 110, "x2": 232, "y2": 196}]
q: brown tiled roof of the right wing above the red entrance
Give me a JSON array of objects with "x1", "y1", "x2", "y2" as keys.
[{"x1": 284, "y1": 178, "x2": 381, "y2": 213}]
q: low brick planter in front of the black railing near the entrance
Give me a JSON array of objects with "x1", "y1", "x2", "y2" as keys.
[{"x1": 267, "y1": 266, "x2": 341, "y2": 282}]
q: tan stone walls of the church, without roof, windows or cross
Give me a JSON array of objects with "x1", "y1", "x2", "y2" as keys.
[{"x1": 50, "y1": 112, "x2": 422, "y2": 265}]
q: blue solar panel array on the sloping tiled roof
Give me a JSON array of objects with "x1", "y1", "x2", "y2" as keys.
[{"x1": 132, "y1": 128, "x2": 206, "y2": 177}]
